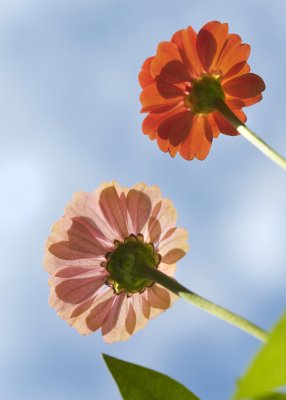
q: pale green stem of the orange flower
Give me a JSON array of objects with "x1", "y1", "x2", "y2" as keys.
[{"x1": 215, "y1": 99, "x2": 286, "y2": 169}]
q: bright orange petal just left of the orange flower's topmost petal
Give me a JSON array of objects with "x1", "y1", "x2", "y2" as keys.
[{"x1": 172, "y1": 26, "x2": 204, "y2": 78}]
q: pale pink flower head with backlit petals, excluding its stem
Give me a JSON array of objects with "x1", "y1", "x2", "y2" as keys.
[{"x1": 44, "y1": 182, "x2": 188, "y2": 342}]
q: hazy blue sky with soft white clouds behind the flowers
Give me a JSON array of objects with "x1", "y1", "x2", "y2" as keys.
[{"x1": 0, "y1": 0, "x2": 286, "y2": 400}]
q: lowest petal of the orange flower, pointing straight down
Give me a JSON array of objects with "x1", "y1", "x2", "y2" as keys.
[{"x1": 180, "y1": 116, "x2": 213, "y2": 160}]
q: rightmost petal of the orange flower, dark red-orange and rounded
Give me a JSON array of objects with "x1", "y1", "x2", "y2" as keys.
[{"x1": 222, "y1": 73, "x2": 265, "y2": 99}]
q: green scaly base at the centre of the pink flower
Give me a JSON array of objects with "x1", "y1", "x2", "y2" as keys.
[{"x1": 106, "y1": 234, "x2": 161, "y2": 294}]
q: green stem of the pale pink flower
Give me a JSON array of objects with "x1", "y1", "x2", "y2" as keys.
[{"x1": 140, "y1": 266, "x2": 268, "y2": 342}]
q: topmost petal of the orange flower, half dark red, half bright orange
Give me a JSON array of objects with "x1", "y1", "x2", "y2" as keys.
[{"x1": 197, "y1": 21, "x2": 228, "y2": 72}]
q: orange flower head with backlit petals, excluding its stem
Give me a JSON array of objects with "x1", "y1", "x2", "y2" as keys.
[{"x1": 139, "y1": 21, "x2": 265, "y2": 160}]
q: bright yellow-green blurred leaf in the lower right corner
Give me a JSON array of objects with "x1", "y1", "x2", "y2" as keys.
[{"x1": 234, "y1": 314, "x2": 286, "y2": 400}]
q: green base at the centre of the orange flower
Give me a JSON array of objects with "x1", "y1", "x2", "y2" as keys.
[{"x1": 185, "y1": 75, "x2": 225, "y2": 114}]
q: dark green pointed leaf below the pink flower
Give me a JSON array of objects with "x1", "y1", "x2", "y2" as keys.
[{"x1": 102, "y1": 354, "x2": 199, "y2": 400}]
